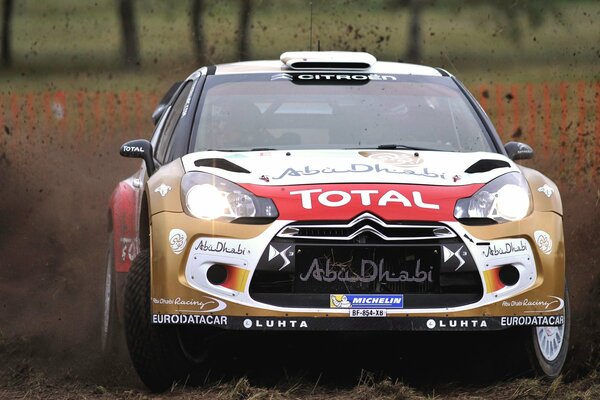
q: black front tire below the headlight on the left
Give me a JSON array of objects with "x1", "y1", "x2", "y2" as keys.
[{"x1": 124, "y1": 250, "x2": 194, "y2": 392}]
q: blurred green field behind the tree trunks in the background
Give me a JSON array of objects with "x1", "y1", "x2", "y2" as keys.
[{"x1": 0, "y1": 0, "x2": 600, "y2": 93}]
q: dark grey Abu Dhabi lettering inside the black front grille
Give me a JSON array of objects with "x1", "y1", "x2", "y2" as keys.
[{"x1": 300, "y1": 257, "x2": 433, "y2": 283}]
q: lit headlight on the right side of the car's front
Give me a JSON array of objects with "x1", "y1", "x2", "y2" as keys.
[{"x1": 454, "y1": 172, "x2": 532, "y2": 224}]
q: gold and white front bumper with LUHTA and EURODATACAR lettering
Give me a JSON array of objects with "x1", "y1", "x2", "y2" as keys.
[{"x1": 152, "y1": 212, "x2": 565, "y2": 331}]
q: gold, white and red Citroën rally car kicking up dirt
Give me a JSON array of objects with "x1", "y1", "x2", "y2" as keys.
[{"x1": 102, "y1": 52, "x2": 570, "y2": 391}]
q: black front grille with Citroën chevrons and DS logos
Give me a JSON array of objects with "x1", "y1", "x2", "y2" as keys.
[{"x1": 250, "y1": 214, "x2": 483, "y2": 308}]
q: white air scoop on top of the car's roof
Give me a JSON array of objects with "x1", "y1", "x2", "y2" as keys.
[{"x1": 280, "y1": 51, "x2": 377, "y2": 71}]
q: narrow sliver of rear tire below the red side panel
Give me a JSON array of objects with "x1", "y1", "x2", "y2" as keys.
[{"x1": 100, "y1": 232, "x2": 123, "y2": 362}]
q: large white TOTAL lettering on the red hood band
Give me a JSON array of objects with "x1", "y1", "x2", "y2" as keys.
[{"x1": 290, "y1": 189, "x2": 440, "y2": 210}]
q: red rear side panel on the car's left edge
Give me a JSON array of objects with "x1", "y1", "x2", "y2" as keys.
[{"x1": 110, "y1": 181, "x2": 140, "y2": 272}]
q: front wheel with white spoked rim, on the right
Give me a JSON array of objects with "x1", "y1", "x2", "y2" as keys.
[{"x1": 526, "y1": 286, "x2": 571, "y2": 379}]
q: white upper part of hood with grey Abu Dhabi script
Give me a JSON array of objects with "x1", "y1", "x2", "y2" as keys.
[{"x1": 182, "y1": 150, "x2": 519, "y2": 186}]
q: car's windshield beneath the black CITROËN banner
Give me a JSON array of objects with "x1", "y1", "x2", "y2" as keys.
[{"x1": 192, "y1": 73, "x2": 493, "y2": 152}]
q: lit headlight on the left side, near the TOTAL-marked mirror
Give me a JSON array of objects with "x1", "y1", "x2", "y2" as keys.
[{"x1": 181, "y1": 172, "x2": 278, "y2": 223}]
